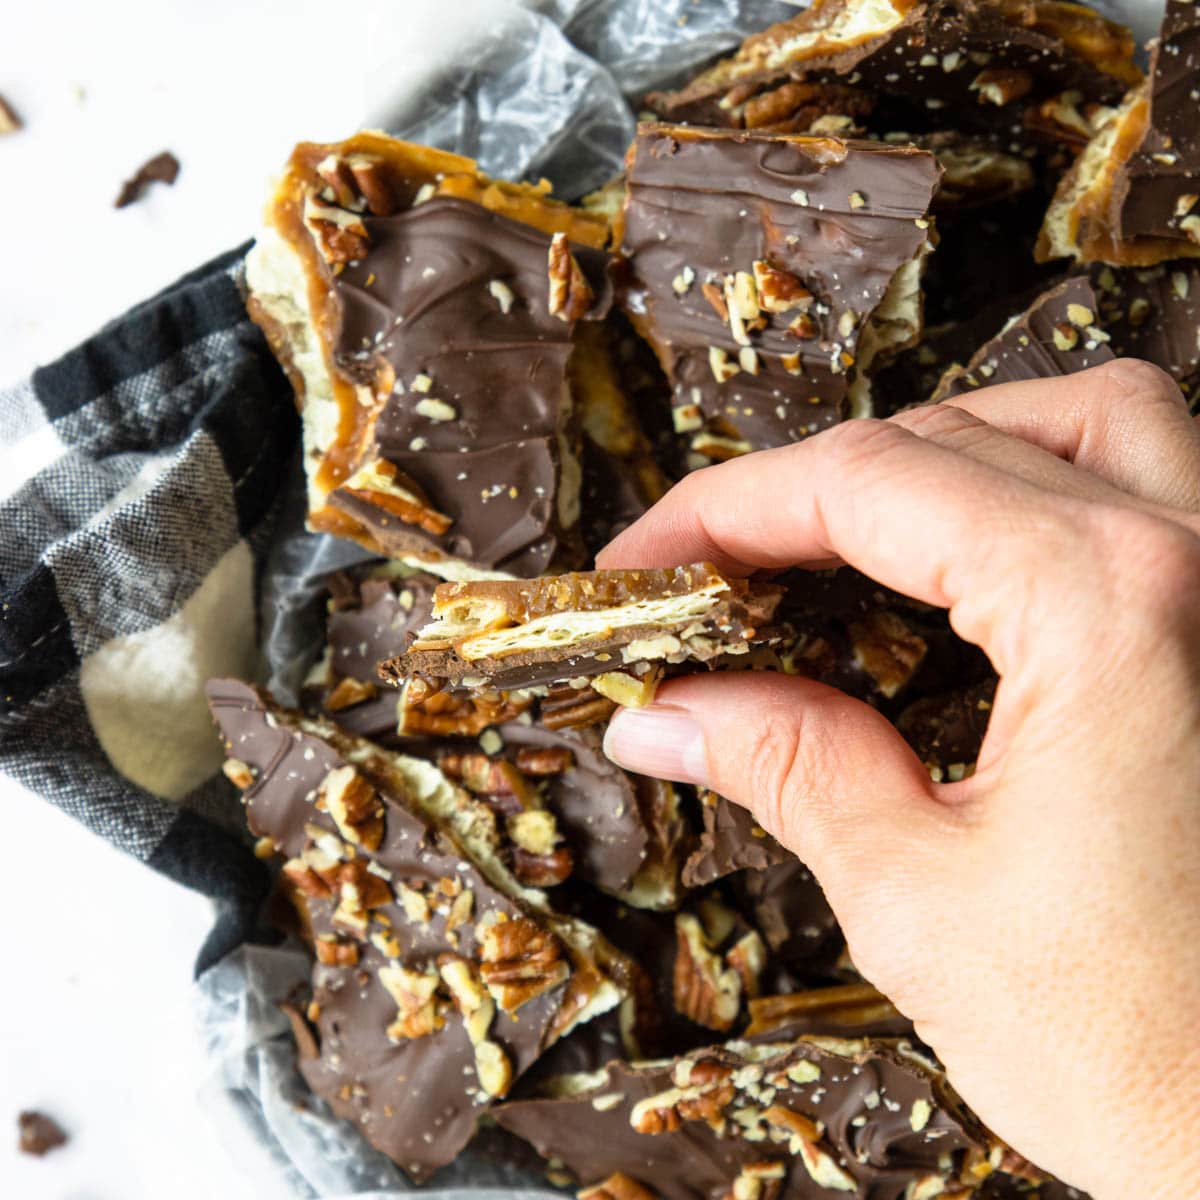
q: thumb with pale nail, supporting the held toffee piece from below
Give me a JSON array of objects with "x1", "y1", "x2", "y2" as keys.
[{"x1": 605, "y1": 672, "x2": 958, "y2": 892}]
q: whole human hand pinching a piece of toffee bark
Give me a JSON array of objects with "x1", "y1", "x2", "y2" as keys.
[{"x1": 599, "y1": 361, "x2": 1200, "y2": 1200}]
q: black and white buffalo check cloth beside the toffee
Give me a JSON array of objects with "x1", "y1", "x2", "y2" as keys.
[{"x1": 0, "y1": 247, "x2": 299, "y2": 967}]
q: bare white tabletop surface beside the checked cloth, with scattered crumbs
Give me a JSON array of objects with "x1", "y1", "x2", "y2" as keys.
[{"x1": 0, "y1": 0, "x2": 486, "y2": 1200}]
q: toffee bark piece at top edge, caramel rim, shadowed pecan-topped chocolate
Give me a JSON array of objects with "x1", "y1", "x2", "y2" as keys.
[{"x1": 647, "y1": 0, "x2": 1140, "y2": 130}]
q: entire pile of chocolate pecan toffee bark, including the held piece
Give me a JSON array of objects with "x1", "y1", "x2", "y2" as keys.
[{"x1": 210, "y1": 0, "x2": 1200, "y2": 1200}]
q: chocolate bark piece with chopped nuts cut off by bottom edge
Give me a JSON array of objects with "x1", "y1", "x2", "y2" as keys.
[{"x1": 493, "y1": 1037, "x2": 1046, "y2": 1200}]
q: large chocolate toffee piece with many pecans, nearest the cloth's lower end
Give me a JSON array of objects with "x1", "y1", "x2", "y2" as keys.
[{"x1": 209, "y1": 680, "x2": 629, "y2": 1178}]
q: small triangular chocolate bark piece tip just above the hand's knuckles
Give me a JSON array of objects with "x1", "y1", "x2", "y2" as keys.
[{"x1": 932, "y1": 276, "x2": 1115, "y2": 403}]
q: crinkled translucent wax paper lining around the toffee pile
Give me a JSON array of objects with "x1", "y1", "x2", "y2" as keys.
[{"x1": 197, "y1": 0, "x2": 1162, "y2": 1200}]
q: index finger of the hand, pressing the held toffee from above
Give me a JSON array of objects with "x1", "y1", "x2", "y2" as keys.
[{"x1": 596, "y1": 420, "x2": 1090, "y2": 670}]
